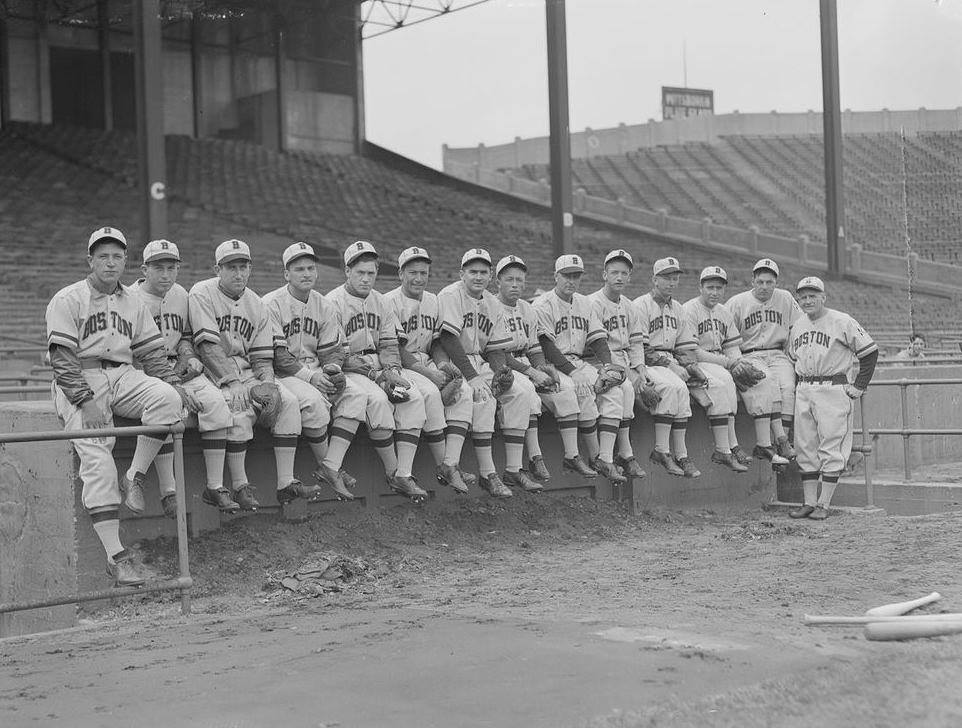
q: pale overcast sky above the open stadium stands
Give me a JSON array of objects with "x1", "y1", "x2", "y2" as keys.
[{"x1": 363, "y1": 0, "x2": 962, "y2": 167}]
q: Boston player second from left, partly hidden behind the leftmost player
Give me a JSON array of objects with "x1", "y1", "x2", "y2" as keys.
[{"x1": 128, "y1": 240, "x2": 240, "y2": 518}]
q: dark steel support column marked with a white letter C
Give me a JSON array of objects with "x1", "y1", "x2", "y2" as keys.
[{"x1": 131, "y1": 0, "x2": 167, "y2": 240}]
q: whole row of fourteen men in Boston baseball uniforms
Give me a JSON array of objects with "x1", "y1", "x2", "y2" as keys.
[{"x1": 47, "y1": 227, "x2": 877, "y2": 585}]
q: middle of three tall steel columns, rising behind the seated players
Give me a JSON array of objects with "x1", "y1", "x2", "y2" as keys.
[{"x1": 545, "y1": 0, "x2": 574, "y2": 255}]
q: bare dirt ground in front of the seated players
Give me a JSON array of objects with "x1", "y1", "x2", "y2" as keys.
[{"x1": 0, "y1": 494, "x2": 962, "y2": 728}]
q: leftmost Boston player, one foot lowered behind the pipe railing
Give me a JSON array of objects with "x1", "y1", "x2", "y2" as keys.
[{"x1": 46, "y1": 227, "x2": 198, "y2": 586}]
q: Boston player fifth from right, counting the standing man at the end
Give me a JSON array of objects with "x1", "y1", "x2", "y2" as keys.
[{"x1": 588, "y1": 250, "x2": 650, "y2": 478}]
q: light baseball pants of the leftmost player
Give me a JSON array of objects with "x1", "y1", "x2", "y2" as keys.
[{"x1": 53, "y1": 364, "x2": 184, "y2": 510}]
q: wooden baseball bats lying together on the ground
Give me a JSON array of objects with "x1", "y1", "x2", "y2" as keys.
[{"x1": 802, "y1": 592, "x2": 962, "y2": 641}]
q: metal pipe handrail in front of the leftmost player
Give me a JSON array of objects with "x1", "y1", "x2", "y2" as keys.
[{"x1": 0, "y1": 422, "x2": 193, "y2": 614}]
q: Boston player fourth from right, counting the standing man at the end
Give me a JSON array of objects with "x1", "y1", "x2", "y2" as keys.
[{"x1": 634, "y1": 258, "x2": 701, "y2": 478}]
